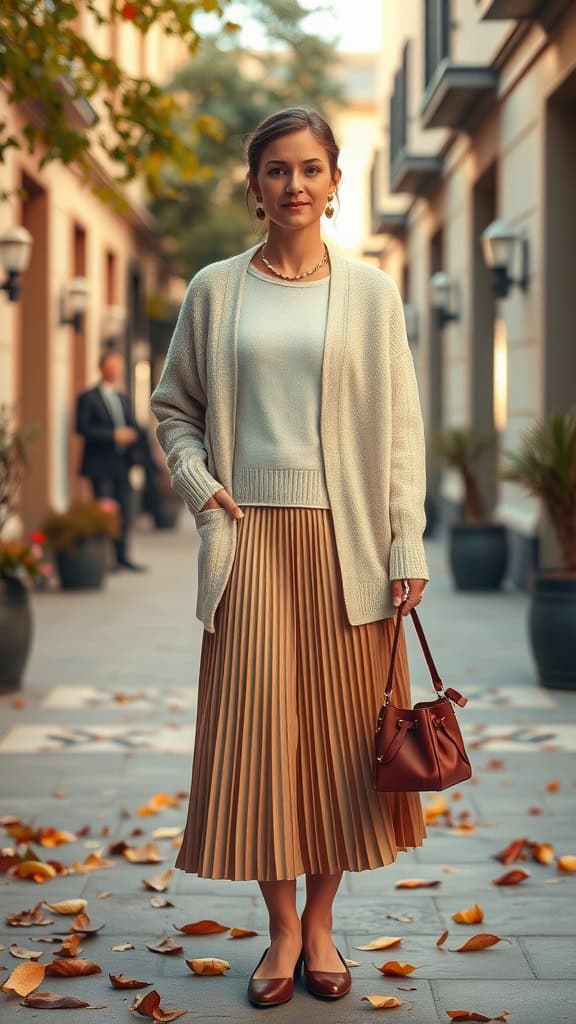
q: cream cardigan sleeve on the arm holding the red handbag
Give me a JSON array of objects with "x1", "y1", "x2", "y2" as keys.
[{"x1": 383, "y1": 284, "x2": 429, "y2": 580}]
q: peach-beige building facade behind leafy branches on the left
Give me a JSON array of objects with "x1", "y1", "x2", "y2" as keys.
[{"x1": 0, "y1": 8, "x2": 184, "y2": 529}]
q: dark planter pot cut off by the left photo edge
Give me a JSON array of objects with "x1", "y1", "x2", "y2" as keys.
[{"x1": 0, "y1": 580, "x2": 33, "y2": 693}]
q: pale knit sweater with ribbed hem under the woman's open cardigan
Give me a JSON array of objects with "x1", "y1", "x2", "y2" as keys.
[{"x1": 233, "y1": 264, "x2": 330, "y2": 508}]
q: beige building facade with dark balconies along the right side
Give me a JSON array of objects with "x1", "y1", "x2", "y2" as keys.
[{"x1": 371, "y1": 0, "x2": 576, "y2": 585}]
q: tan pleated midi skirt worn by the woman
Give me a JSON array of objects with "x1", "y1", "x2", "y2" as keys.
[{"x1": 176, "y1": 506, "x2": 426, "y2": 882}]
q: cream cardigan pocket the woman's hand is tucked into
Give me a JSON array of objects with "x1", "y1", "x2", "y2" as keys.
[{"x1": 195, "y1": 507, "x2": 236, "y2": 633}]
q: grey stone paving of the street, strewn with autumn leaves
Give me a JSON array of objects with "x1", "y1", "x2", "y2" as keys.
[{"x1": 0, "y1": 520, "x2": 576, "y2": 1024}]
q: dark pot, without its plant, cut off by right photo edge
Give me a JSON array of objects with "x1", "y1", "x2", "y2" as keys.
[{"x1": 529, "y1": 572, "x2": 576, "y2": 690}]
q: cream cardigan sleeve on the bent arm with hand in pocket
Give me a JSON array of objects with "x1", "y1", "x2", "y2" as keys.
[{"x1": 150, "y1": 279, "x2": 222, "y2": 515}]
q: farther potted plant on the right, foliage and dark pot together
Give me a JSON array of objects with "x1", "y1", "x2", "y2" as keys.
[{"x1": 438, "y1": 427, "x2": 507, "y2": 590}]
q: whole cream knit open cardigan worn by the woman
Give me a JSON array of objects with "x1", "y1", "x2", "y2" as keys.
[{"x1": 151, "y1": 241, "x2": 429, "y2": 633}]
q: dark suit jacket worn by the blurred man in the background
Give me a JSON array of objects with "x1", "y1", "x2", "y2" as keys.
[{"x1": 76, "y1": 385, "x2": 139, "y2": 476}]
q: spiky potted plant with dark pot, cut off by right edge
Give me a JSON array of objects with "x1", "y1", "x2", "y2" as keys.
[{"x1": 502, "y1": 410, "x2": 576, "y2": 689}]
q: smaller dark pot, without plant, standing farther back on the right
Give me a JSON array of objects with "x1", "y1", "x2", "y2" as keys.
[{"x1": 449, "y1": 523, "x2": 507, "y2": 590}]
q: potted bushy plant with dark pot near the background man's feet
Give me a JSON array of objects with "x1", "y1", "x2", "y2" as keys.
[{"x1": 42, "y1": 498, "x2": 120, "y2": 590}]
